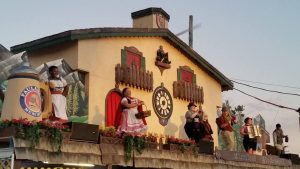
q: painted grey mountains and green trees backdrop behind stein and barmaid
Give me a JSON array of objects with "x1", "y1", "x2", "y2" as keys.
[{"x1": 0, "y1": 44, "x2": 88, "y2": 123}]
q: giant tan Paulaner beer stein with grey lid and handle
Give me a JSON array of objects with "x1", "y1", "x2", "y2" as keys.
[{"x1": 1, "y1": 66, "x2": 52, "y2": 121}]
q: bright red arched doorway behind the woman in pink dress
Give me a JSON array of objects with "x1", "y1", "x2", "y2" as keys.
[{"x1": 105, "y1": 89, "x2": 122, "y2": 128}]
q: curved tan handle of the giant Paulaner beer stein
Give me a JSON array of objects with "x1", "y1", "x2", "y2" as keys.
[{"x1": 40, "y1": 82, "x2": 52, "y2": 119}]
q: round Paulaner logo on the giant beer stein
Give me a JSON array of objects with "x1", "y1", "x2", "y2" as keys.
[{"x1": 20, "y1": 86, "x2": 41, "y2": 117}]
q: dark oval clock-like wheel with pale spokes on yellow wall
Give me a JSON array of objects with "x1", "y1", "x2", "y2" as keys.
[{"x1": 152, "y1": 84, "x2": 173, "y2": 126}]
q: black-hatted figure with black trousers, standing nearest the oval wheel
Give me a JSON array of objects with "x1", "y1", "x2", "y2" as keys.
[{"x1": 184, "y1": 102, "x2": 201, "y2": 140}]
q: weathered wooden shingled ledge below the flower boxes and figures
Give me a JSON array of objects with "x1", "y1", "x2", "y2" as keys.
[{"x1": 0, "y1": 127, "x2": 300, "y2": 169}]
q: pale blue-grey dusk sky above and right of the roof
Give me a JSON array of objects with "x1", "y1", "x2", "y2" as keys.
[{"x1": 0, "y1": 0, "x2": 300, "y2": 154}]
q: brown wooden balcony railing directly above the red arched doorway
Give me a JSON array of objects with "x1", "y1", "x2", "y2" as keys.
[{"x1": 115, "y1": 64, "x2": 153, "y2": 91}]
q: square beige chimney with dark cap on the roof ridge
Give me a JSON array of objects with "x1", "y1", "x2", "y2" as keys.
[{"x1": 131, "y1": 8, "x2": 170, "y2": 29}]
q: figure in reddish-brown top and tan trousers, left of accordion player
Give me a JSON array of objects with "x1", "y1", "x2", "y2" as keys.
[{"x1": 216, "y1": 106, "x2": 236, "y2": 151}]
